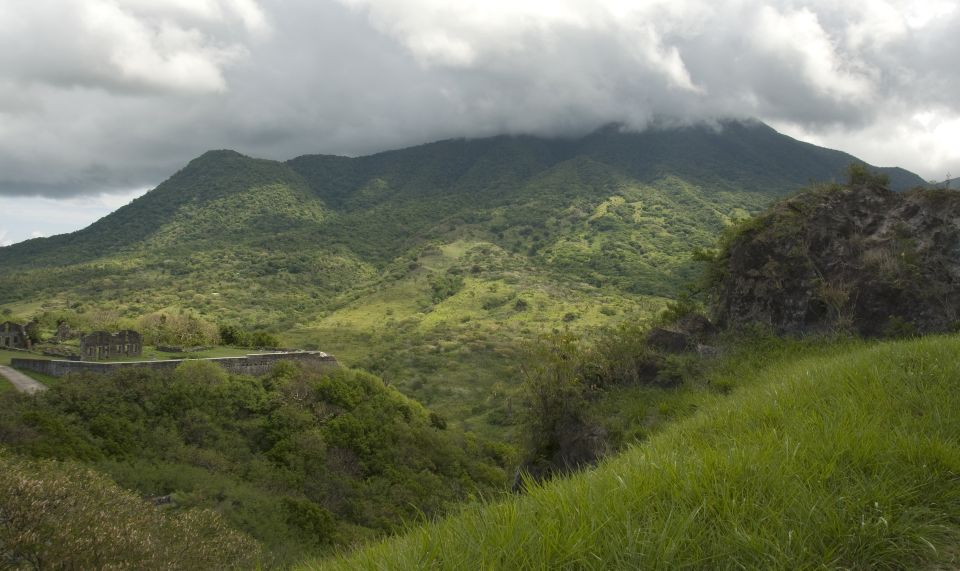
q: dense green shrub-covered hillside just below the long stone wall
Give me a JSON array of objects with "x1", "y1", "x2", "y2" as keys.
[{"x1": 0, "y1": 361, "x2": 515, "y2": 568}]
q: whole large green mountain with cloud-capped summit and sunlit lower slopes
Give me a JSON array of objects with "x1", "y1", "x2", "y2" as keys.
[{"x1": 0, "y1": 122, "x2": 923, "y2": 436}]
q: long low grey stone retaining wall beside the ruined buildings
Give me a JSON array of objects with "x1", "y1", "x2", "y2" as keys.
[{"x1": 10, "y1": 351, "x2": 338, "y2": 377}]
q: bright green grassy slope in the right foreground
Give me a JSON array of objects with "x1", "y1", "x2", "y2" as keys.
[{"x1": 307, "y1": 336, "x2": 960, "y2": 570}]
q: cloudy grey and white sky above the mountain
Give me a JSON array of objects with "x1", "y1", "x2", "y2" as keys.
[{"x1": 0, "y1": 0, "x2": 960, "y2": 245}]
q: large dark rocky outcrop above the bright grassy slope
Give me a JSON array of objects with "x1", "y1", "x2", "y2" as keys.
[{"x1": 714, "y1": 186, "x2": 960, "y2": 336}]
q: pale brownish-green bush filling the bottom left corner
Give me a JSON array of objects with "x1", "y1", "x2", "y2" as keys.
[{"x1": 0, "y1": 452, "x2": 260, "y2": 569}]
